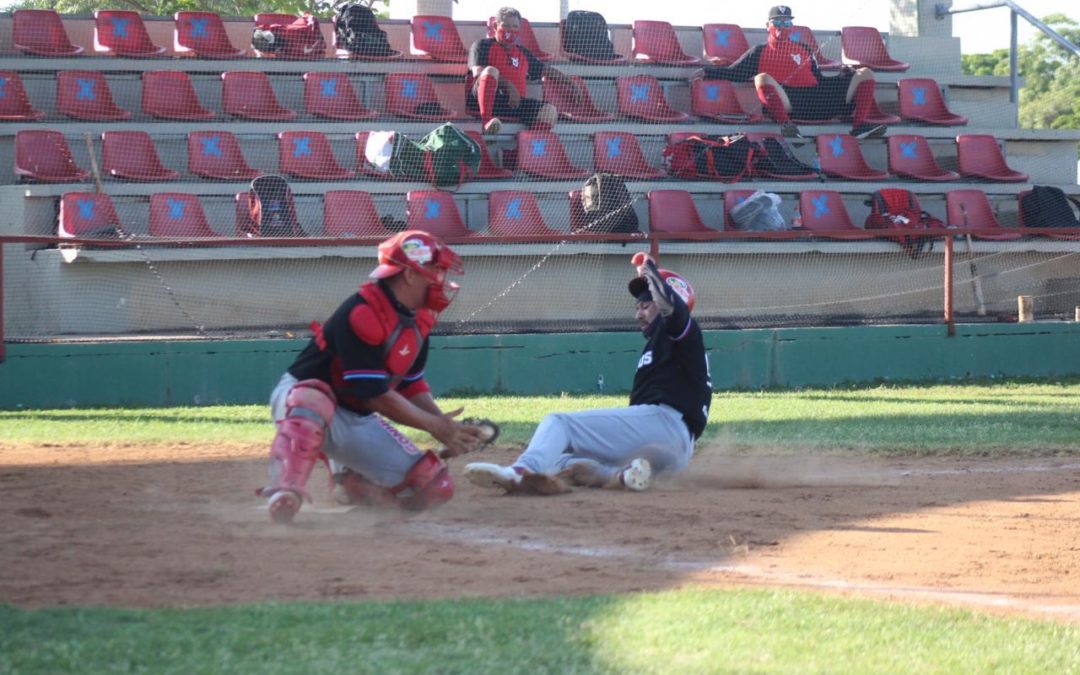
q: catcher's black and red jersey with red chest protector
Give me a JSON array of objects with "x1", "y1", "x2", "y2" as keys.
[{"x1": 288, "y1": 281, "x2": 435, "y2": 414}]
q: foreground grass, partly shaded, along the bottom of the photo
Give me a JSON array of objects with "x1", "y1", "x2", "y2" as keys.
[{"x1": 0, "y1": 589, "x2": 1080, "y2": 675}]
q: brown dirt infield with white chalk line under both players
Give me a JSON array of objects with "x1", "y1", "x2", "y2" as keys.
[{"x1": 0, "y1": 445, "x2": 1080, "y2": 621}]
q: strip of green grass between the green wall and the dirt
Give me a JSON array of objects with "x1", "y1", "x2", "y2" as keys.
[{"x1": 0, "y1": 381, "x2": 1080, "y2": 455}]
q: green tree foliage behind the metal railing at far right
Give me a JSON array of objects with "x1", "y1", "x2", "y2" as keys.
[{"x1": 963, "y1": 14, "x2": 1080, "y2": 129}]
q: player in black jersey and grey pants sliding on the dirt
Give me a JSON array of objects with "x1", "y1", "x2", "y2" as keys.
[{"x1": 465, "y1": 253, "x2": 713, "y2": 495}]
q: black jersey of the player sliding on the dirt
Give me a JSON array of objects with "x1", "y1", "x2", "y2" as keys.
[{"x1": 630, "y1": 300, "x2": 713, "y2": 438}]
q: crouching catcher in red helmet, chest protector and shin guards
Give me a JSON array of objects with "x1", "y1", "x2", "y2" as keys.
[{"x1": 259, "y1": 230, "x2": 485, "y2": 523}]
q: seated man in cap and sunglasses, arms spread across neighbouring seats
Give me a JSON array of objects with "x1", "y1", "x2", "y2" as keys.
[{"x1": 704, "y1": 4, "x2": 886, "y2": 138}]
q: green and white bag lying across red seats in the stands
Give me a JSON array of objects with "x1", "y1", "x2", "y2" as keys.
[{"x1": 366, "y1": 122, "x2": 481, "y2": 188}]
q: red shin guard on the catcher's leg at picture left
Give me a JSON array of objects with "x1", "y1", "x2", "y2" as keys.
[{"x1": 268, "y1": 380, "x2": 337, "y2": 499}]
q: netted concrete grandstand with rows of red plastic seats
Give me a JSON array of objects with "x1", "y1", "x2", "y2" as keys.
[{"x1": 0, "y1": 5, "x2": 1080, "y2": 340}]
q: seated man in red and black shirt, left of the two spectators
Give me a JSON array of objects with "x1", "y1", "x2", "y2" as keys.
[{"x1": 465, "y1": 8, "x2": 580, "y2": 134}]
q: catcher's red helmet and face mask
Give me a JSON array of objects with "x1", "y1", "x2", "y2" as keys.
[{"x1": 370, "y1": 230, "x2": 464, "y2": 312}]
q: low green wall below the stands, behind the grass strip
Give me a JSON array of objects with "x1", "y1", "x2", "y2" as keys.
[{"x1": 0, "y1": 323, "x2": 1080, "y2": 409}]
